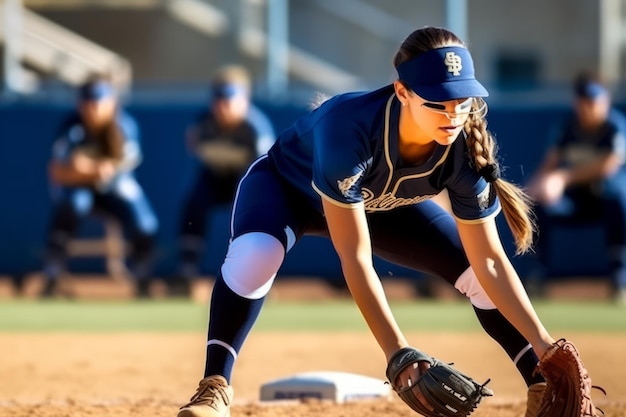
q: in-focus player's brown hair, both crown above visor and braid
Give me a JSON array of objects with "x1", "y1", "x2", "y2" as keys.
[{"x1": 393, "y1": 27, "x2": 535, "y2": 254}]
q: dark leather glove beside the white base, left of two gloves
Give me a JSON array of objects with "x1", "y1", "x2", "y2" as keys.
[{"x1": 387, "y1": 347, "x2": 493, "y2": 417}]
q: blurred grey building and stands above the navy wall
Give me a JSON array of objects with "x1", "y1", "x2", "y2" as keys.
[{"x1": 0, "y1": 0, "x2": 626, "y2": 100}]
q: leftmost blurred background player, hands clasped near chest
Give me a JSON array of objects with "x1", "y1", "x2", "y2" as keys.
[{"x1": 42, "y1": 79, "x2": 158, "y2": 296}]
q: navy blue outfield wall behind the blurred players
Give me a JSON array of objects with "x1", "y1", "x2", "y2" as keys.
[{"x1": 0, "y1": 96, "x2": 616, "y2": 281}]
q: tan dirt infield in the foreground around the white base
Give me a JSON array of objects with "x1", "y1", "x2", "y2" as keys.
[{"x1": 0, "y1": 332, "x2": 626, "y2": 417}]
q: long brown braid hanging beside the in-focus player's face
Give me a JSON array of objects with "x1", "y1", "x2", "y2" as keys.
[{"x1": 464, "y1": 102, "x2": 535, "y2": 255}]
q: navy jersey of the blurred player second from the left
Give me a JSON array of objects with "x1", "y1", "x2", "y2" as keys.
[{"x1": 193, "y1": 105, "x2": 276, "y2": 176}]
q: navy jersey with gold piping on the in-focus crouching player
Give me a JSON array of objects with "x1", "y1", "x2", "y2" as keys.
[{"x1": 268, "y1": 86, "x2": 500, "y2": 222}]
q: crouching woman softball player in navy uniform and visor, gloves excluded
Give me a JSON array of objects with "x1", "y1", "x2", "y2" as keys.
[{"x1": 178, "y1": 27, "x2": 596, "y2": 417}]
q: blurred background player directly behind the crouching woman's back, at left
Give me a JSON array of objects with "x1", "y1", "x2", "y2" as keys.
[{"x1": 172, "y1": 65, "x2": 275, "y2": 295}]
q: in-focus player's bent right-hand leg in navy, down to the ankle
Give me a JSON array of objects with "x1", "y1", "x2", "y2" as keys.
[{"x1": 369, "y1": 201, "x2": 543, "y2": 400}]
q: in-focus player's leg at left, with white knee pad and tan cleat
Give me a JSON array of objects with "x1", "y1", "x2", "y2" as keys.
[{"x1": 178, "y1": 158, "x2": 320, "y2": 417}]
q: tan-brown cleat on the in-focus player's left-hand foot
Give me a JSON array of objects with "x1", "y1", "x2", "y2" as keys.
[{"x1": 177, "y1": 375, "x2": 233, "y2": 417}]
